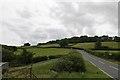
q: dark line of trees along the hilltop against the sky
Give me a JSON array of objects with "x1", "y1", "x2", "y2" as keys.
[{"x1": 37, "y1": 35, "x2": 120, "y2": 45}]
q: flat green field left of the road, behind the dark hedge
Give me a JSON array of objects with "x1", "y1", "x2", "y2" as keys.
[{"x1": 14, "y1": 47, "x2": 71, "y2": 57}]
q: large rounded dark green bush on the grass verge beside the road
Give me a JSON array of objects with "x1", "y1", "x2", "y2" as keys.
[{"x1": 52, "y1": 51, "x2": 86, "y2": 72}]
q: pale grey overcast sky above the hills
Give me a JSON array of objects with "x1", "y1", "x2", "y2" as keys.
[{"x1": 0, "y1": 0, "x2": 118, "y2": 45}]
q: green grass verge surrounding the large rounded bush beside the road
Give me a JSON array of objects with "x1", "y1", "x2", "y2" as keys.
[{"x1": 33, "y1": 59, "x2": 110, "y2": 78}]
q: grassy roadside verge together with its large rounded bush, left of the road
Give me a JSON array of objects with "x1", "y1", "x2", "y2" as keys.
[{"x1": 3, "y1": 51, "x2": 110, "y2": 78}]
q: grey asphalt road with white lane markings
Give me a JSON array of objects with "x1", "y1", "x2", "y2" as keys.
[{"x1": 78, "y1": 50, "x2": 120, "y2": 79}]
